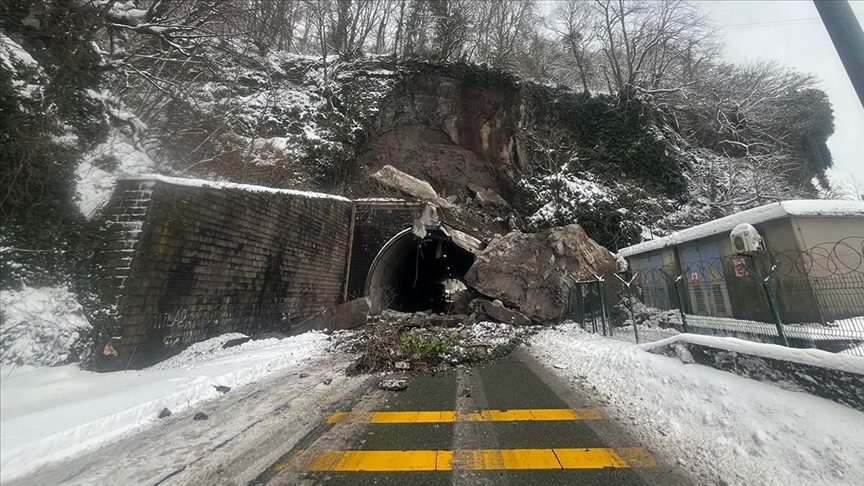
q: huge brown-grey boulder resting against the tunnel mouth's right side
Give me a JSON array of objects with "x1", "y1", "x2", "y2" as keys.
[{"x1": 465, "y1": 224, "x2": 616, "y2": 323}]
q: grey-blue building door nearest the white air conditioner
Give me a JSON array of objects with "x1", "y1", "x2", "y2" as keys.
[{"x1": 681, "y1": 241, "x2": 732, "y2": 317}]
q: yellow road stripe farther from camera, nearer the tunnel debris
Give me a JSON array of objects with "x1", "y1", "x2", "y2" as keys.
[{"x1": 326, "y1": 408, "x2": 603, "y2": 424}]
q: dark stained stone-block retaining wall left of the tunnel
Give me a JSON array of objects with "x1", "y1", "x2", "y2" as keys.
[{"x1": 105, "y1": 178, "x2": 354, "y2": 366}]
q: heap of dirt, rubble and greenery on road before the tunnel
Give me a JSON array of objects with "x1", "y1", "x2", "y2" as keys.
[{"x1": 333, "y1": 310, "x2": 541, "y2": 374}]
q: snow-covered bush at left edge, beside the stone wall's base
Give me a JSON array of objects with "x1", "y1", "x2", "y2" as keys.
[{"x1": 0, "y1": 287, "x2": 91, "y2": 366}]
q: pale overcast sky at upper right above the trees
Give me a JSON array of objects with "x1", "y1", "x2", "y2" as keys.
[{"x1": 696, "y1": 0, "x2": 864, "y2": 188}]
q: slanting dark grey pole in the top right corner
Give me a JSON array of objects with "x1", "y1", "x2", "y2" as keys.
[{"x1": 813, "y1": 0, "x2": 864, "y2": 108}]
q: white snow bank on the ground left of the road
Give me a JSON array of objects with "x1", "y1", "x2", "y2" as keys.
[{"x1": 0, "y1": 332, "x2": 330, "y2": 481}]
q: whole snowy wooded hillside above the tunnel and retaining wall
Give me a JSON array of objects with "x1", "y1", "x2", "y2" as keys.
[{"x1": 0, "y1": 0, "x2": 834, "y2": 292}]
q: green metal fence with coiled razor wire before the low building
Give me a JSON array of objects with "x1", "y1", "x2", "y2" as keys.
[{"x1": 568, "y1": 238, "x2": 864, "y2": 356}]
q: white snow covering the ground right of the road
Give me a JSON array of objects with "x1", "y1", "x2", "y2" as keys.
[{"x1": 528, "y1": 324, "x2": 864, "y2": 486}]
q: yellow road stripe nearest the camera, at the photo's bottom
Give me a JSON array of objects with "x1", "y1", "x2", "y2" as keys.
[{"x1": 309, "y1": 447, "x2": 659, "y2": 471}]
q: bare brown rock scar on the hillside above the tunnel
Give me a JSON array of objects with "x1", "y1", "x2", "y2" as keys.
[{"x1": 358, "y1": 74, "x2": 526, "y2": 203}]
